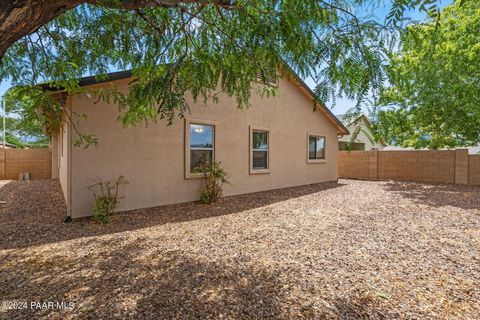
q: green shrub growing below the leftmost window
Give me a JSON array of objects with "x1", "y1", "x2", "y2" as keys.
[{"x1": 199, "y1": 161, "x2": 229, "y2": 204}]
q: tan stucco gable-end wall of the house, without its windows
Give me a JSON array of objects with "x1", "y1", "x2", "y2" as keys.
[{"x1": 71, "y1": 80, "x2": 338, "y2": 217}]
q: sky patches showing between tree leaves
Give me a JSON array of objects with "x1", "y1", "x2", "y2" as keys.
[{"x1": 0, "y1": 0, "x2": 454, "y2": 114}]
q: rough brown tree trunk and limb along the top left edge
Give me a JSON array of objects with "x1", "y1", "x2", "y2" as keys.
[{"x1": 0, "y1": 0, "x2": 232, "y2": 62}]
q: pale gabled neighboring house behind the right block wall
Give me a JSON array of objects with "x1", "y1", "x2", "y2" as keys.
[{"x1": 337, "y1": 114, "x2": 385, "y2": 151}]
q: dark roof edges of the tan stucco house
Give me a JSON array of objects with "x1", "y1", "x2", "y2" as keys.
[{"x1": 41, "y1": 64, "x2": 350, "y2": 135}]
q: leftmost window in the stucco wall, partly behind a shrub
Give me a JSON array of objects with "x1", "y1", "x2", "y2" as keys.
[{"x1": 186, "y1": 122, "x2": 215, "y2": 174}]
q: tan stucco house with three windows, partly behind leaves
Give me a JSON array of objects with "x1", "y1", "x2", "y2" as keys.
[{"x1": 48, "y1": 71, "x2": 348, "y2": 218}]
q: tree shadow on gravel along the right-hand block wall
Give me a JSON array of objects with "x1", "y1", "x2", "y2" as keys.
[{"x1": 385, "y1": 181, "x2": 480, "y2": 210}]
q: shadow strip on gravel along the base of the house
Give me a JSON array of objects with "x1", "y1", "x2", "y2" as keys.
[{"x1": 0, "y1": 180, "x2": 344, "y2": 249}]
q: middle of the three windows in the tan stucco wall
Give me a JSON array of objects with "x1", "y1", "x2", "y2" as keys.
[{"x1": 250, "y1": 129, "x2": 270, "y2": 173}]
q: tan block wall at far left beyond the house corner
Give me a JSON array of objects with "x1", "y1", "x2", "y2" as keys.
[{"x1": 0, "y1": 148, "x2": 52, "y2": 180}]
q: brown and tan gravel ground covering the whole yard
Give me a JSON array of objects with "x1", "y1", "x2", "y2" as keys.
[{"x1": 0, "y1": 180, "x2": 480, "y2": 319}]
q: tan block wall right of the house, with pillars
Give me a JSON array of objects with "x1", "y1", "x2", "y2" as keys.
[{"x1": 338, "y1": 149, "x2": 480, "y2": 185}]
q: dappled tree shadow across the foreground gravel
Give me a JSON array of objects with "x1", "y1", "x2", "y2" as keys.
[{"x1": 0, "y1": 241, "x2": 399, "y2": 319}]
